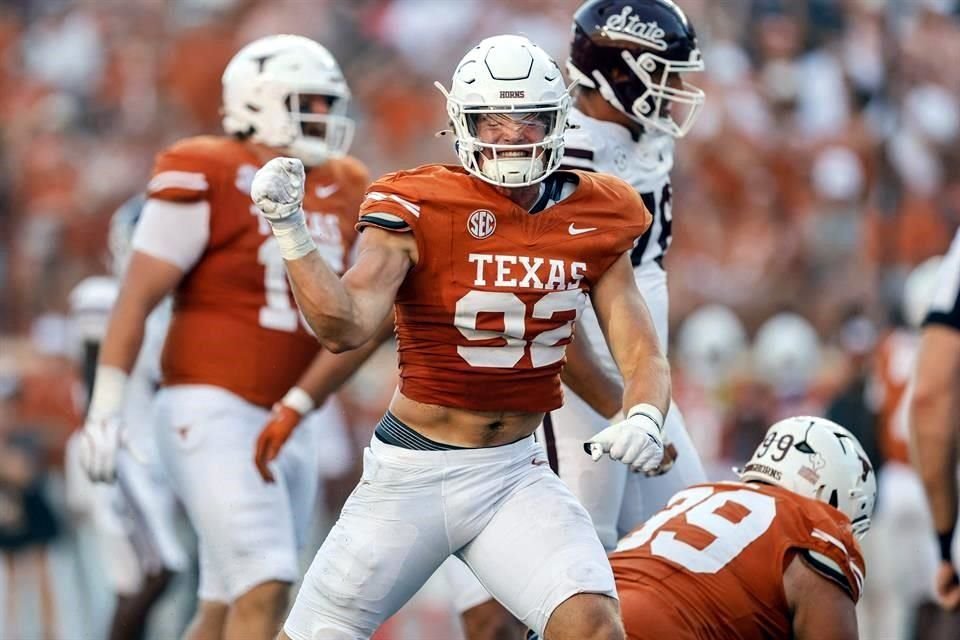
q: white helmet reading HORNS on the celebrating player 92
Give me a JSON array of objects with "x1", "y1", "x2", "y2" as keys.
[{"x1": 434, "y1": 35, "x2": 570, "y2": 187}]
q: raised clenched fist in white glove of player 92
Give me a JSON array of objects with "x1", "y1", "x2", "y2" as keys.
[{"x1": 250, "y1": 158, "x2": 315, "y2": 260}]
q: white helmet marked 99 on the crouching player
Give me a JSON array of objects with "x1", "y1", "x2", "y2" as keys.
[{"x1": 737, "y1": 416, "x2": 877, "y2": 538}]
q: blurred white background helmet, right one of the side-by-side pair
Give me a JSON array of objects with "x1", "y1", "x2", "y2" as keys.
[{"x1": 753, "y1": 313, "x2": 821, "y2": 394}]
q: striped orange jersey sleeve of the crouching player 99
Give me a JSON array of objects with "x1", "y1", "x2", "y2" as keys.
[{"x1": 796, "y1": 505, "x2": 866, "y2": 603}]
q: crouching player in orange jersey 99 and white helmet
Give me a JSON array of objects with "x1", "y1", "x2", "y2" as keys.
[{"x1": 610, "y1": 417, "x2": 877, "y2": 640}]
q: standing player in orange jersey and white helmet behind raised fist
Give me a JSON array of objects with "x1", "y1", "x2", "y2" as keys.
[{"x1": 79, "y1": 35, "x2": 382, "y2": 640}]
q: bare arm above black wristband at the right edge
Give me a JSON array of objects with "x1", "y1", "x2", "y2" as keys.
[{"x1": 910, "y1": 325, "x2": 960, "y2": 532}]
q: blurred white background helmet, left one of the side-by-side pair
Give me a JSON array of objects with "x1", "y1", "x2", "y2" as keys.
[{"x1": 677, "y1": 304, "x2": 747, "y2": 387}]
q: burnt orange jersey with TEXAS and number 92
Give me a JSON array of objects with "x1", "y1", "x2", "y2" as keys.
[{"x1": 358, "y1": 165, "x2": 650, "y2": 412}]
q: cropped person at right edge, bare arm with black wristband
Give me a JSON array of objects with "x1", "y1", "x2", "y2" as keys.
[{"x1": 909, "y1": 231, "x2": 960, "y2": 611}]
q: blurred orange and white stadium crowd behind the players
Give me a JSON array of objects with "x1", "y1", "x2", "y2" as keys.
[{"x1": 0, "y1": 0, "x2": 960, "y2": 640}]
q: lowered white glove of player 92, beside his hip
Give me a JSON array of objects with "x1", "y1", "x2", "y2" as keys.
[{"x1": 583, "y1": 404, "x2": 663, "y2": 473}]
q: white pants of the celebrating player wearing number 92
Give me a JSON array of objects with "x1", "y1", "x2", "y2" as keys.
[{"x1": 284, "y1": 436, "x2": 616, "y2": 640}]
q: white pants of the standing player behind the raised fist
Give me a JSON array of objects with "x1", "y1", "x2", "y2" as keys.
[{"x1": 156, "y1": 385, "x2": 335, "y2": 603}]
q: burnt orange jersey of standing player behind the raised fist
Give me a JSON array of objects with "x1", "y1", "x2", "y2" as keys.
[{"x1": 147, "y1": 137, "x2": 367, "y2": 407}]
